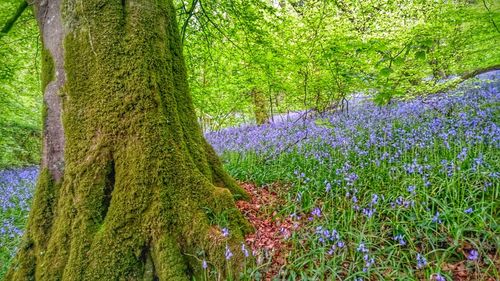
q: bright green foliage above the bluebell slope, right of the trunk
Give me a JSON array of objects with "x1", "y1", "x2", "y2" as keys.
[{"x1": 178, "y1": 0, "x2": 500, "y2": 129}]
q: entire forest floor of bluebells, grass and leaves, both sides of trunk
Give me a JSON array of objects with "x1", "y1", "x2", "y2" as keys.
[{"x1": 0, "y1": 80, "x2": 500, "y2": 281}]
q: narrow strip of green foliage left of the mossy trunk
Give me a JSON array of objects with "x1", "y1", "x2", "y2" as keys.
[{"x1": 0, "y1": 0, "x2": 42, "y2": 168}]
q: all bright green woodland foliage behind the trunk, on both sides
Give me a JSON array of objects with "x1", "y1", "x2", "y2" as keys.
[{"x1": 0, "y1": 0, "x2": 500, "y2": 166}]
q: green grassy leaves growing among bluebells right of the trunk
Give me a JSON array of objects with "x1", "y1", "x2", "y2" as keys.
[{"x1": 215, "y1": 89, "x2": 500, "y2": 280}]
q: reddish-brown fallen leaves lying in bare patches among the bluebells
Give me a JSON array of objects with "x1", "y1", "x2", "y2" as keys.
[{"x1": 236, "y1": 182, "x2": 500, "y2": 281}]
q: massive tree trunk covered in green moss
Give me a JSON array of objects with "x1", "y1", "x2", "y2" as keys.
[{"x1": 6, "y1": 0, "x2": 249, "y2": 281}]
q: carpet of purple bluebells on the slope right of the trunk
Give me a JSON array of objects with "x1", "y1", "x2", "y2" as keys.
[{"x1": 206, "y1": 84, "x2": 500, "y2": 280}]
